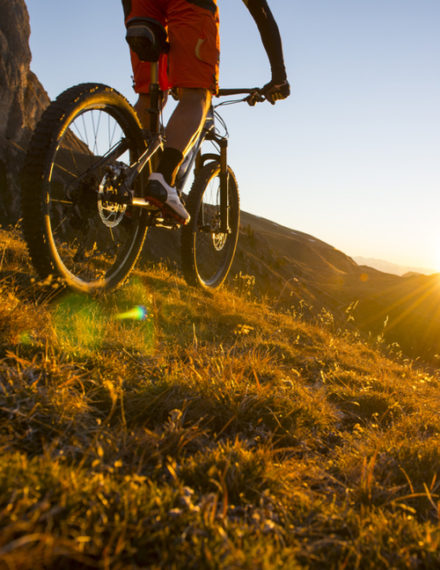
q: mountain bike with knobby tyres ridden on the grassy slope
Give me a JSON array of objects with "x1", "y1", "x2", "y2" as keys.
[{"x1": 21, "y1": 18, "x2": 264, "y2": 293}]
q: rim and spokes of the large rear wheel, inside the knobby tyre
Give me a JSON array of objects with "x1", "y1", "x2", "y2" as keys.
[{"x1": 45, "y1": 104, "x2": 141, "y2": 289}]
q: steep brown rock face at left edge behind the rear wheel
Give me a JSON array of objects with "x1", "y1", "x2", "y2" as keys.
[{"x1": 0, "y1": 0, "x2": 49, "y2": 224}]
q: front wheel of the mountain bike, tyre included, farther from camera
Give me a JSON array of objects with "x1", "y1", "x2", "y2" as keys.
[{"x1": 182, "y1": 162, "x2": 240, "y2": 289}]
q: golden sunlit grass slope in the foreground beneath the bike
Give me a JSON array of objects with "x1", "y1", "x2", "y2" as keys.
[{"x1": 0, "y1": 232, "x2": 440, "y2": 570}]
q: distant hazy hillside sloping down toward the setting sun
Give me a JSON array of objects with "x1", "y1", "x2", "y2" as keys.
[{"x1": 145, "y1": 212, "x2": 440, "y2": 366}]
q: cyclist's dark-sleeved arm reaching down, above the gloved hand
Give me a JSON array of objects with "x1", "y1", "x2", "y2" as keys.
[{"x1": 243, "y1": 0, "x2": 287, "y2": 83}]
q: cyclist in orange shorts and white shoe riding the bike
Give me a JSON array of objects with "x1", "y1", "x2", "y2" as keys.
[{"x1": 122, "y1": 0, "x2": 290, "y2": 224}]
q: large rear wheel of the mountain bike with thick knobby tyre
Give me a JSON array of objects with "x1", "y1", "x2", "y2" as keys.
[{"x1": 22, "y1": 84, "x2": 146, "y2": 293}]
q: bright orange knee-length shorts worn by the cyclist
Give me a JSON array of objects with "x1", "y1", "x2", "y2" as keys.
[{"x1": 123, "y1": 0, "x2": 220, "y2": 93}]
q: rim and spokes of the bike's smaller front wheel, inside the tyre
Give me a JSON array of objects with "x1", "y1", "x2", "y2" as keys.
[{"x1": 194, "y1": 168, "x2": 237, "y2": 287}]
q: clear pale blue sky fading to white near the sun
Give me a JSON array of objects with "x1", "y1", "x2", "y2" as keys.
[{"x1": 27, "y1": 0, "x2": 440, "y2": 271}]
